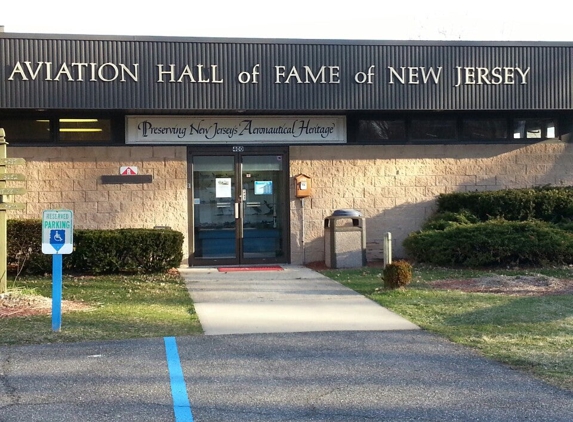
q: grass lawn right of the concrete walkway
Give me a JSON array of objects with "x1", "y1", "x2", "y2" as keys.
[{"x1": 323, "y1": 267, "x2": 573, "y2": 391}]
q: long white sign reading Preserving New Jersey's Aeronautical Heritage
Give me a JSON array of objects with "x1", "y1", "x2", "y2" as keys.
[{"x1": 126, "y1": 116, "x2": 346, "y2": 145}]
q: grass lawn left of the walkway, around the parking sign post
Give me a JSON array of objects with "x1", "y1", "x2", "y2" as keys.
[{"x1": 0, "y1": 274, "x2": 202, "y2": 345}]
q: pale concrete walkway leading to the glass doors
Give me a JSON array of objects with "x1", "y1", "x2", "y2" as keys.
[{"x1": 179, "y1": 265, "x2": 419, "y2": 335}]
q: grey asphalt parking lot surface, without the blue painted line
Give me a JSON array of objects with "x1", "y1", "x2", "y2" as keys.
[{"x1": 0, "y1": 330, "x2": 573, "y2": 422}]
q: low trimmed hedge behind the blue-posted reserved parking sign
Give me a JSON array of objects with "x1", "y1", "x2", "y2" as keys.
[{"x1": 7, "y1": 220, "x2": 183, "y2": 274}]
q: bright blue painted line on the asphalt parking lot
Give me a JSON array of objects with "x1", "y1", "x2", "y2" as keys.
[{"x1": 163, "y1": 337, "x2": 193, "y2": 422}]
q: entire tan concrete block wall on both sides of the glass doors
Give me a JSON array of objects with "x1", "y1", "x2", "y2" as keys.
[{"x1": 8, "y1": 142, "x2": 573, "y2": 264}]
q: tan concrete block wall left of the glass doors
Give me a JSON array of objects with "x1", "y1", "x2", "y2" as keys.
[{"x1": 8, "y1": 146, "x2": 188, "y2": 255}]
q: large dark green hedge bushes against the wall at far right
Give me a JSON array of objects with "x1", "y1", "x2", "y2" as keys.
[{"x1": 404, "y1": 187, "x2": 573, "y2": 267}]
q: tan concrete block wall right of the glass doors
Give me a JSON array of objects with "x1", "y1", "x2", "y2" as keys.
[{"x1": 290, "y1": 141, "x2": 573, "y2": 264}]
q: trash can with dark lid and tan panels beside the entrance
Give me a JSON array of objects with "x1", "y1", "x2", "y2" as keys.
[{"x1": 324, "y1": 209, "x2": 366, "y2": 268}]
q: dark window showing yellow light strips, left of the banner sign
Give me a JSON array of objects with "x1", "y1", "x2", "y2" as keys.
[{"x1": 58, "y1": 118, "x2": 111, "y2": 142}]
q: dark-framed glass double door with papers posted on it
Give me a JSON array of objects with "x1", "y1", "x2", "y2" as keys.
[{"x1": 189, "y1": 150, "x2": 288, "y2": 266}]
